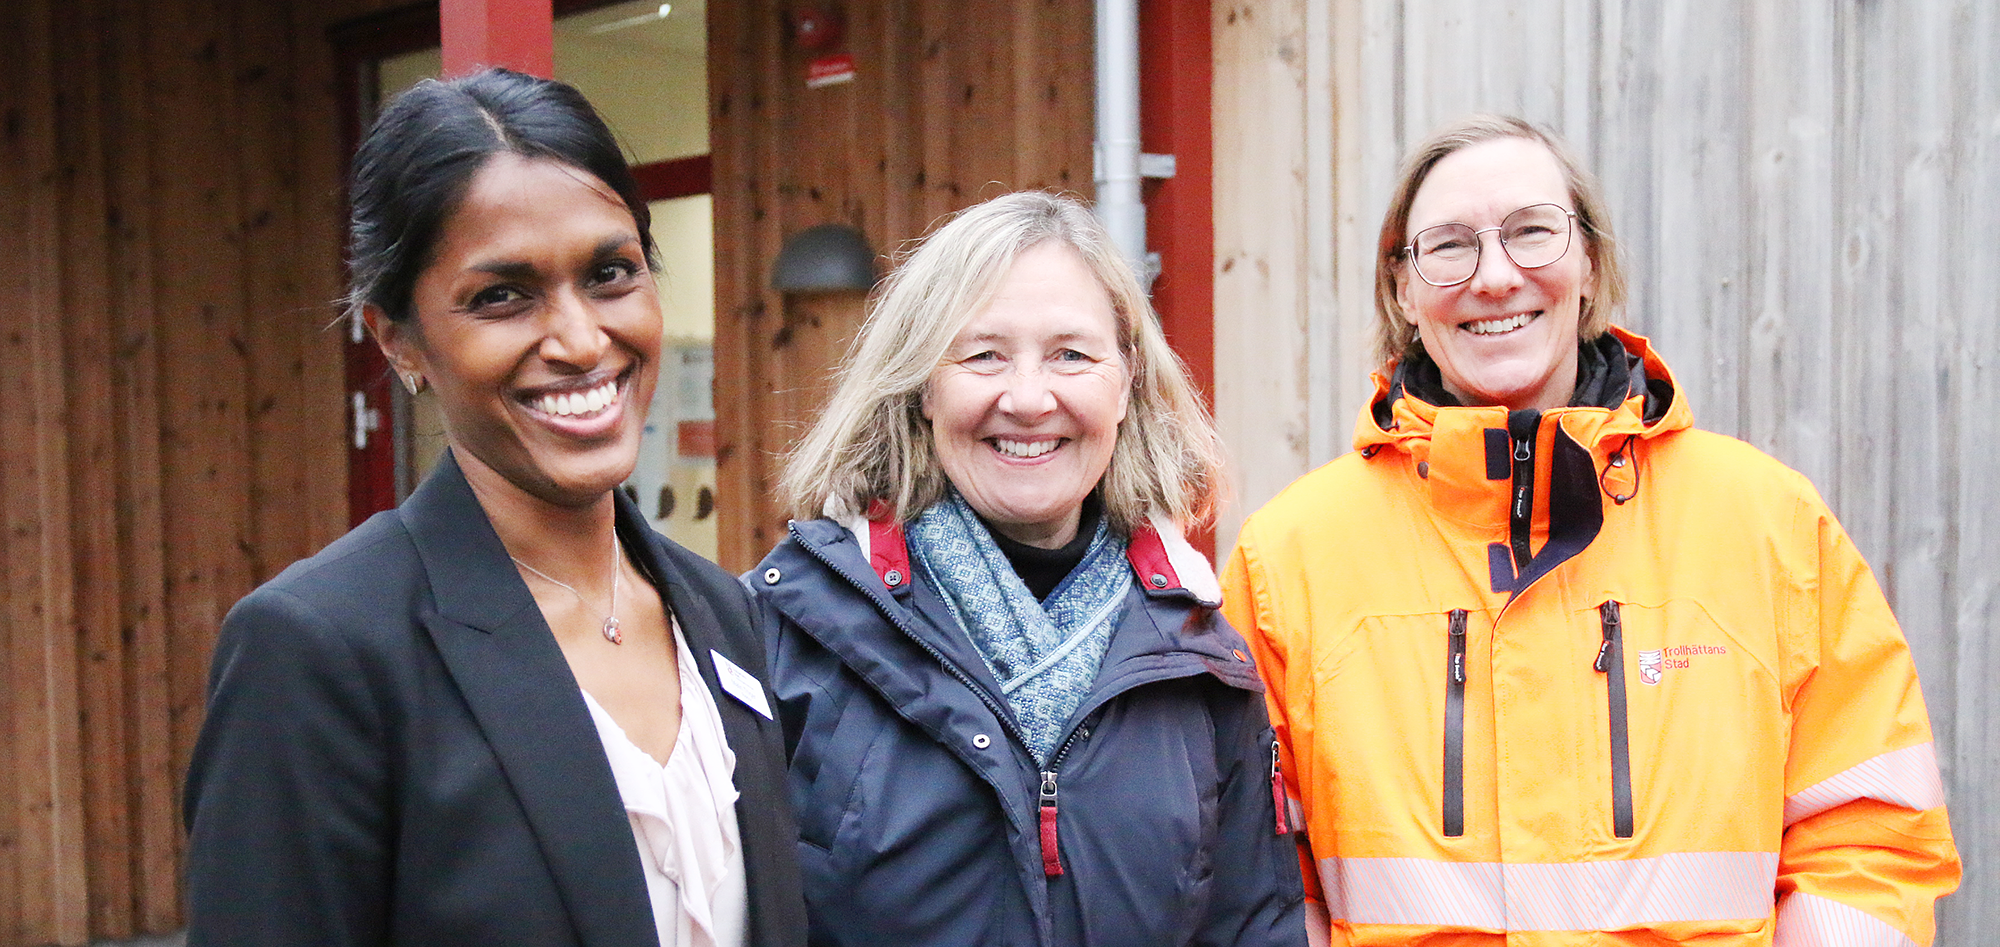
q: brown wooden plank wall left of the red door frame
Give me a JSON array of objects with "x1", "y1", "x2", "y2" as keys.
[{"x1": 0, "y1": 0, "x2": 374, "y2": 945}]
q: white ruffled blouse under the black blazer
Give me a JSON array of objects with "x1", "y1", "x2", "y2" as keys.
[{"x1": 584, "y1": 619, "x2": 748, "y2": 947}]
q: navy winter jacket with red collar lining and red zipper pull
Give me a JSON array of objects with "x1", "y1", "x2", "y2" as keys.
[{"x1": 746, "y1": 519, "x2": 1306, "y2": 947}]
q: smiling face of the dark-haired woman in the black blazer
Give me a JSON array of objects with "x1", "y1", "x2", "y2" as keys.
[{"x1": 366, "y1": 154, "x2": 660, "y2": 507}]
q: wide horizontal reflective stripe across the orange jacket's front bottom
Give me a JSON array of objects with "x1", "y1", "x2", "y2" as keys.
[{"x1": 1318, "y1": 851, "x2": 1778, "y2": 931}]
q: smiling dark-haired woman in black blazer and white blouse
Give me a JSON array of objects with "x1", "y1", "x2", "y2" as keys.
[{"x1": 186, "y1": 70, "x2": 804, "y2": 947}]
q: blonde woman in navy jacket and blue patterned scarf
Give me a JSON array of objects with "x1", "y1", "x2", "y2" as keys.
[{"x1": 746, "y1": 194, "x2": 1306, "y2": 947}]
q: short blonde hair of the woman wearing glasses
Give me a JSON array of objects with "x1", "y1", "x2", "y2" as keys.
[{"x1": 1376, "y1": 114, "x2": 1626, "y2": 364}]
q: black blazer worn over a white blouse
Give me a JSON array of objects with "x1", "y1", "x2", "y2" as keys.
[{"x1": 184, "y1": 456, "x2": 806, "y2": 947}]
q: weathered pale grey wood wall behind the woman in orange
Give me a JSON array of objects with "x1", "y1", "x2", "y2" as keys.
[{"x1": 1214, "y1": 0, "x2": 2000, "y2": 945}]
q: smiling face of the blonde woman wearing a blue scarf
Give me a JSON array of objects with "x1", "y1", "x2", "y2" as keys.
[{"x1": 924, "y1": 242, "x2": 1132, "y2": 549}]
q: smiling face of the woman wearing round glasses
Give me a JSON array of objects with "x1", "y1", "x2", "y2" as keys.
[{"x1": 1396, "y1": 138, "x2": 1590, "y2": 410}]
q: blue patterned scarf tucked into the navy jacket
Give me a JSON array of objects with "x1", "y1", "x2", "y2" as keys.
[{"x1": 904, "y1": 491, "x2": 1132, "y2": 765}]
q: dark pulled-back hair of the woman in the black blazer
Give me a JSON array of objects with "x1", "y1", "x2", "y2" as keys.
[{"x1": 346, "y1": 68, "x2": 658, "y2": 322}]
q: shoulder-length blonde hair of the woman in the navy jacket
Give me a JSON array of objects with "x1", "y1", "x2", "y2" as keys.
[{"x1": 780, "y1": 192, "x2": 1222, "y2": 533}]
